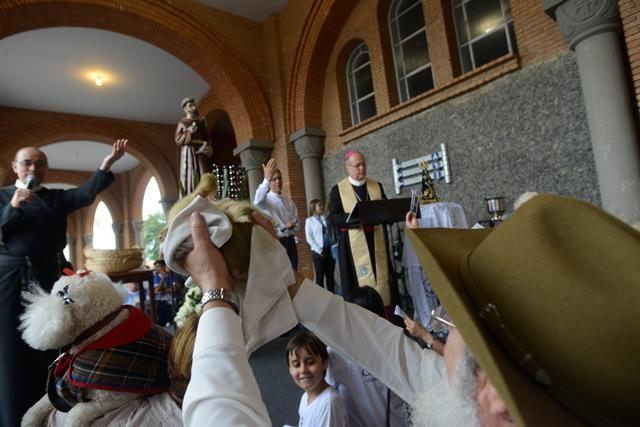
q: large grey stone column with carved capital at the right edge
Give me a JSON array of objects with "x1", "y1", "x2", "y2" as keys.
[{"x1": 542, "y1": 0, "x2": 640, "y2": 223}]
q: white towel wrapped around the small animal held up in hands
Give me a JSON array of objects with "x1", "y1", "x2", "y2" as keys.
[{"x1": 164, "y1": 196, "x2": 298, "y2": 354}]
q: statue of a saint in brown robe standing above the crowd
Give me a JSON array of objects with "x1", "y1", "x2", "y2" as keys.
[{"x1": 175, "y1": 98, "x2": 213, "y2": 196}]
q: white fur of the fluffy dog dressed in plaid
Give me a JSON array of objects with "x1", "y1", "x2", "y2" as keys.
[{"x1": 20, "y1": 272, "x2": 142, "y2": 427}]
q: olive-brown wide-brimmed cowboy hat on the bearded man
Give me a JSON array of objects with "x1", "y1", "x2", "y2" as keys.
[{"x1": 410, "y1": 195, "x2": 640, "y2": 426}]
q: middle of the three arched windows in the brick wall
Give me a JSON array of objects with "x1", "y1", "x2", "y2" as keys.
[{"x1": 389, "y1": 0, "x2": 434, "y2": 102}]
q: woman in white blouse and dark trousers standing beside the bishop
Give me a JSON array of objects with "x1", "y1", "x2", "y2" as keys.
[{"x1": 304, "y1": 199, "x2": 335, "y2": 292}]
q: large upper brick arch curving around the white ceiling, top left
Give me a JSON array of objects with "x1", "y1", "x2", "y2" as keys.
[{"x1": 0, "y1": 0, "x2": 274, "y2": 141}]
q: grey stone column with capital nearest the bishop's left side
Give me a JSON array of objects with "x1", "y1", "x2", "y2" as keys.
[{"x1": 289, "y1": 128, "x2": 326, "y2": 205}]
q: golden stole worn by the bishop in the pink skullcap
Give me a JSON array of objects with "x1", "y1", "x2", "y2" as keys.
[{"x1": 338, "y1": 178, "x2": 391, "y2": 306}]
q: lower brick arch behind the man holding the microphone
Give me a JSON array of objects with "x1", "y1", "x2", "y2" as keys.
[{"x1": 2, "y1": 116, "x2": 178, "y2": 201}]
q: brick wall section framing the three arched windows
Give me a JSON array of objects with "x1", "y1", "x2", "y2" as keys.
[{"x1": 306, "y1": 0, "x2": 568, "y2": 153}]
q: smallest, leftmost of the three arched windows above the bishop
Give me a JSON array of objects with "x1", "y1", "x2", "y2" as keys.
[{"x1": 347, "y1": 43, "x2": 376, "y2": 125}]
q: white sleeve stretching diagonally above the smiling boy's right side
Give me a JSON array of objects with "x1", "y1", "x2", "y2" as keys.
[{"x1": 293, "y1": 279, "x2": 445, "y2": 403}]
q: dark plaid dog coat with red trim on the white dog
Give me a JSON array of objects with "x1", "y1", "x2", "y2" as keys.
[{"x1": 48, "y1": 306, "x2": 171, "y2": 412}]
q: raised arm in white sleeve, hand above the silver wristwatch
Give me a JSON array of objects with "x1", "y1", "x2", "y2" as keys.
[{"x1": 182, "y1": 213, "x2": 271, "y2": 427}]
